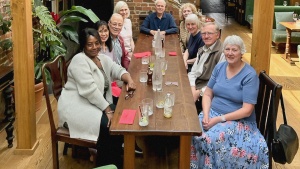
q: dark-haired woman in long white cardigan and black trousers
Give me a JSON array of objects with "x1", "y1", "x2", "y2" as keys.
[{"x1": 58, "y1": 28, "x2": 136, "y2": 166}]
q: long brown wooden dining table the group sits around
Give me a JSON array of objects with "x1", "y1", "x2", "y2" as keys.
[{"x1": 110, "y1": 34, "x2": 202, "y2": 169}]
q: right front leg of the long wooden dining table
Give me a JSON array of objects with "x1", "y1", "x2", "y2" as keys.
[{"x1": 179, "y1": 136, "x2": 192, "y2": 169}]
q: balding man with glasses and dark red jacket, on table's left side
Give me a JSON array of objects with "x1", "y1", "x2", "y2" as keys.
[{"x1": 108, "y1": 13, "x2": 130, "y2": 70}]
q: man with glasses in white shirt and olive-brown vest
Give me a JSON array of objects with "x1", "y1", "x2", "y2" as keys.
[{"x1": 188, "y1": 22, "x2": 225, "y2": 113}]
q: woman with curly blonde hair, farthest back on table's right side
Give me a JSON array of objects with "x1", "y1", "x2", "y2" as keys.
[{"x1": 179, "y1": 3, "x2": 197, "y2": 53}]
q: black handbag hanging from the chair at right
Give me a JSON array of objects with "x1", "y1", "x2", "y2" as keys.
[{"x1": 271, "y1": 95, "x2": 299, "y2": 164}]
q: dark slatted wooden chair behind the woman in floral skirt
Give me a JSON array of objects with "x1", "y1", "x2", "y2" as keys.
[{"x1": 255, "y1": 71, "x2": 282, "y2": 169}]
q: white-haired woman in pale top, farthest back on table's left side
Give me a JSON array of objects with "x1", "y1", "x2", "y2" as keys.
[{"x1": 114, "y1": 1, "x2": 134, "y2": 59}]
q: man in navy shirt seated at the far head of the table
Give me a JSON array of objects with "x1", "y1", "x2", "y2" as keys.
[{"x1": 140, "y1": 0, "x2": 178, "y2": 35}]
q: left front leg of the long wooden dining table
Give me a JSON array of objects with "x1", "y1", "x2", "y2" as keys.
[{"x1": 124, "y1": 135, "x2": 135, "y2": 169}]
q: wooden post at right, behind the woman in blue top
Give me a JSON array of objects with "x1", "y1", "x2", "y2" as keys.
[{"x1": 250, "y1": 0, "x2": 274, "y2": 73}]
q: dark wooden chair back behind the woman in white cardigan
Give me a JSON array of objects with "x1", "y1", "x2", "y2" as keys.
[{"x1": 42, "y1": 55, "x2": 67, "y2": 136}]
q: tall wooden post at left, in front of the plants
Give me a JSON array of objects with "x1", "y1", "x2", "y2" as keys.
[{"x1": 11, "y1": 0, "x2": 38, "y2": 154}]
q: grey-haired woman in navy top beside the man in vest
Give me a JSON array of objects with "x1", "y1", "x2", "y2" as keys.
[{"x1": 183, "y1": 14, "x2": 204, "y2": 73}]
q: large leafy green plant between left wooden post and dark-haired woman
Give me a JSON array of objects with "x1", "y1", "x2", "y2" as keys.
[{"x1": 33, "y1": 5, "x2": 99, "y2": 111}]
